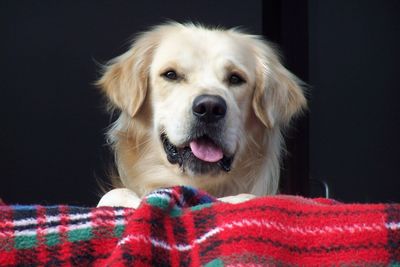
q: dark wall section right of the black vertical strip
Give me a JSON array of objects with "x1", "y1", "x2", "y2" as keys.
[{"x1": 309, "y1": 0, "x2": 400, "y2": 202}]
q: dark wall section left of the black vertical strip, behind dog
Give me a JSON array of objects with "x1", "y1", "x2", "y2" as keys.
[{"x1": 0, "y1": 0, "x2": 262, "y2": 205}]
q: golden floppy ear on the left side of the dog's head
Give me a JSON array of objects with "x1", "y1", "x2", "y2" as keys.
[{"x1": 96, "y1": 32, "x2": 156, "y2": 117}]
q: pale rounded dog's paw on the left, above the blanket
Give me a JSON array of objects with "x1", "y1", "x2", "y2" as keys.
[{"x1": 97, "y1": 188, "x2": 141, "y2": 209}]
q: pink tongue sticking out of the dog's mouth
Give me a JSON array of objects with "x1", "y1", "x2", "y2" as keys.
[{"x1": 190, "y1": 139, "x2": 224, "y2": 162}]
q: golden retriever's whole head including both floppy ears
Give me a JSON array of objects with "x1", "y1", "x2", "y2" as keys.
[{"x1": 98, "y1": 24, "x2": 305, "y2": 195}]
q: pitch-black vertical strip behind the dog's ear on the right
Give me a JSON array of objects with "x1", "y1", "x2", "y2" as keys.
[{"x1": 263, "y1": 0, "x2": 310, "y2": 196}]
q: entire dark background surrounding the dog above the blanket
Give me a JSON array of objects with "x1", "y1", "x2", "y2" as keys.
[{"x1": 0, "y1": 0, "x2": 400, "y2": 205}]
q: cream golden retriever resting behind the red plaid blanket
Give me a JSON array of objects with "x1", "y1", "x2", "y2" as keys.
[{"x1": 97, "y1": 22, "x2": 306, "y2": 206}]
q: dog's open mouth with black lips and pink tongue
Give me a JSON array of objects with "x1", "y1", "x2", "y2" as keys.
[{"x1": 161, "y1": 133, "x2": 234, "y2": 174}]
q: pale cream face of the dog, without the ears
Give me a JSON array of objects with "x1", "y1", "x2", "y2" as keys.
[{"x1": 149, "y1": 29, "x2": 256, "y2": 176}]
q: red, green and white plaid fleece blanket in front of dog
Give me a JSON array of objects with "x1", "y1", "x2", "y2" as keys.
[{"x1": 0, "y1": 187, "x2": 400, "y2": 267}]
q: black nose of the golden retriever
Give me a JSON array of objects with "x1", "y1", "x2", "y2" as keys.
[{"x1": 192, "y1": 95, "x2": 226, "y2": 122}]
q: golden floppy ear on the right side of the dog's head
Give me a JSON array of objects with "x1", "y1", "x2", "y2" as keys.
[{"x1": 252, "y1": 40, "x2": 307, "y2": 128}]
